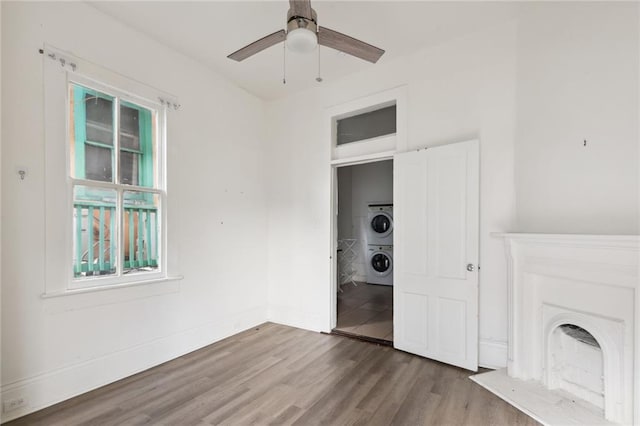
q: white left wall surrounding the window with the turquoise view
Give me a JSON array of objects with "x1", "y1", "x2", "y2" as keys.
[{"x1": 1, "y1": 2, "x2": 267, "y2": 420}]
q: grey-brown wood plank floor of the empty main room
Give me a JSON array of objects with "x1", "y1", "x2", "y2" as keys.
[{"x1": 9, "y1": 323, "x2": 537, "y2": 426}]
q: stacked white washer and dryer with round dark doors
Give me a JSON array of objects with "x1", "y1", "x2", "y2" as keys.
[{"x1": 367, "y1": 203, "x2": 393, "y2": 285}]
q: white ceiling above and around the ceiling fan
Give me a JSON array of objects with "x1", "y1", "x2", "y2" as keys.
[{"x1": 91, "y1": 0, "x2": 515, "y2": 100}]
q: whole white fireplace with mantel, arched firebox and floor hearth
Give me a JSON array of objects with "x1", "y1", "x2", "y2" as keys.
[{"x1": 474, "y1": 234, "x2": 640, "y2": 424}]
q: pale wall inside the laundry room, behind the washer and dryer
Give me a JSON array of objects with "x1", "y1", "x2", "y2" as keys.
[{"x1": 338, "y1": 160, "x2": 393, "y2": 281}]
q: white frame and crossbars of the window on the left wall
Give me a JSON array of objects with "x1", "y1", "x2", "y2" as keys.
[{"x1": 64, "y1": 73, "x2": 168, "y2": 291}]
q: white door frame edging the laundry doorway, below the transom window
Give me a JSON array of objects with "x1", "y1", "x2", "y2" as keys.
[{"x1": 329, "y1": 150, "x2": 396, "y2": 331}]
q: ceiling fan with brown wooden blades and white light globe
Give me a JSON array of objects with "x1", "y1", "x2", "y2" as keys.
[{"x1": 227, "y1": 0, "x2": 384, "y2": 63}]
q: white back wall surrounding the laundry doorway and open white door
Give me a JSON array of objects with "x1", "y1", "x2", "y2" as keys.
[{"x1": 267, "y1": 24, "x2": 516, "y2": 364}]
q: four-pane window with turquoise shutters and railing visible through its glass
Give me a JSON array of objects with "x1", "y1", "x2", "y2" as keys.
[{"x1": 68, "y1": 82, "x2": 165, "y2": 286}]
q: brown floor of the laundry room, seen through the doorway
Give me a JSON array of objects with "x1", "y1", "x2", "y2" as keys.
[{"x1": 335, "y1": 282, "x2": 393, "y2": 342}]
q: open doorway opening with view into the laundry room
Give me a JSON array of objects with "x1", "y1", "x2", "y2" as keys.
[{"x1": 333, "y1": 160, "x2": 394, "y2": 344}]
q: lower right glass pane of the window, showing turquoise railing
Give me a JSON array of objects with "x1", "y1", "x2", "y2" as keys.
[{"x1": 123, "y1": 191, "x2": 160, "y2": 274}]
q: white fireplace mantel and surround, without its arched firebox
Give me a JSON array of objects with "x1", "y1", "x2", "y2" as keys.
[{"x1": 477, "y1": 233, "x2": 640, "y2": 424}]
